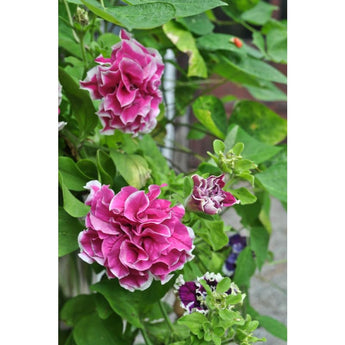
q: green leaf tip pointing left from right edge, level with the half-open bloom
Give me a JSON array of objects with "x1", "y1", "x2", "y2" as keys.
[{"x1": 255, "y1": 162, "x2": 287, "y2": 203}]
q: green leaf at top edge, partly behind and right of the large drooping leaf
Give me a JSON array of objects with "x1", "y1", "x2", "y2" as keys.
[{"x1": 128, "y1": 0, "x2": 227, "y2": 17}]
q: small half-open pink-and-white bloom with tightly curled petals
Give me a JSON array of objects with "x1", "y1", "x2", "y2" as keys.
[{"x1": 187, "y1": 175, "x2": 239, "y2": 214}]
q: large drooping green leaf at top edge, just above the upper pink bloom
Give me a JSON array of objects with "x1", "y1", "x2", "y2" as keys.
[{"x1": 81, "y1": 0, "x2": 175, "y2": 30}]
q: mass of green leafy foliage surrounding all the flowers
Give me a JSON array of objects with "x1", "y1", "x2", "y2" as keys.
[{"x1": 58, "y1": 0, "x2": 287, "y2": 345}]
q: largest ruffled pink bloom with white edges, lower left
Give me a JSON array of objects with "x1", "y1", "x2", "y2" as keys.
[{"x1": 78, "y1": 181, "x2": 194, "y2": 291}]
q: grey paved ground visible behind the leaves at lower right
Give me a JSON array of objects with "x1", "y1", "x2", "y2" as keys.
[{"x1": 224, "y1": 199, "x2": 287, "y2": 345}]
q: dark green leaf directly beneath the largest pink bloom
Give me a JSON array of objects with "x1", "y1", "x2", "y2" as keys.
[{"x1": 91, "y1": 279, "x2": 174, "y2": 328}]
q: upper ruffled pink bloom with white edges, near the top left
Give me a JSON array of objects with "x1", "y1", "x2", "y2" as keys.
[{"x1": 80, "y1": 30, "x2": 164, "y2": 135}]
